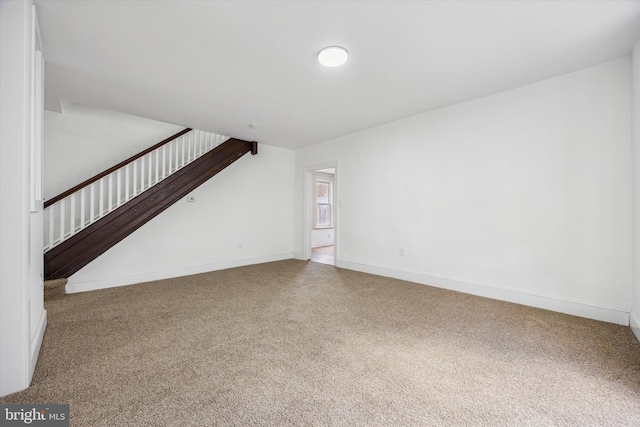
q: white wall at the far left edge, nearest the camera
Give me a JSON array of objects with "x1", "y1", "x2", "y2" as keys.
[{"x1": 0, "y1": 1, "x2": 47, "y2": 395}]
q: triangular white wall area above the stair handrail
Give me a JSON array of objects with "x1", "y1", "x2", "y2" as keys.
[{"x1": 44, "y1": 104, "x2": 186, "y2": 199}]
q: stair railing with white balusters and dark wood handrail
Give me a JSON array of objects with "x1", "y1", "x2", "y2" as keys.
[{"x1": 44, "y1": 129, "x2": 229, "y2": 252}]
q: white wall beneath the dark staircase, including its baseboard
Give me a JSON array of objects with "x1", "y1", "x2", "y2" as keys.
[{"x1": 67, "y1": 145, "x2": 294, "y2": 292}]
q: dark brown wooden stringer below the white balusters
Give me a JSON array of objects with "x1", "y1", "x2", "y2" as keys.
[{"x1": 44, "y1": 138, "x2": 257, "y2": 280}]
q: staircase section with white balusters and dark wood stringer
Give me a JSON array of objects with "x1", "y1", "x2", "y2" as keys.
[{"x1": 44, "y1": 129, "x2": 257, "y2": 280}]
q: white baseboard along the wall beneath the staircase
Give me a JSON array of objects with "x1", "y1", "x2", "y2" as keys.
[{"x1": 66, "y1": 253, "x2": 293, "y2": 294}]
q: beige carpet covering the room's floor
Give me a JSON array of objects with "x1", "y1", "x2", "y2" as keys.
[{"x1": 0, "y1": 260, "x2": 640, "y2": 426}]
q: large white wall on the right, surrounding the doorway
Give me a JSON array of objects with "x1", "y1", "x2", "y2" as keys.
[{"x1": 294, "y1": 57, "x2": 631, "y2": 324}]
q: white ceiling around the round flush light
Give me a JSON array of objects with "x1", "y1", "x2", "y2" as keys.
[{"x1": 35, "y1": 0, "x2": 640, "y2": 148}]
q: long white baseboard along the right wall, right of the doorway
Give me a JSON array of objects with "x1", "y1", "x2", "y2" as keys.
[{"x1": 336, "y1": 259, "x2": 640, "y2": 326}]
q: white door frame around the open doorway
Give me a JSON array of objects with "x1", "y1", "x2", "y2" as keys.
[{"x1": 302, "y1": 161, "x2": 340, "y2": 264}]
